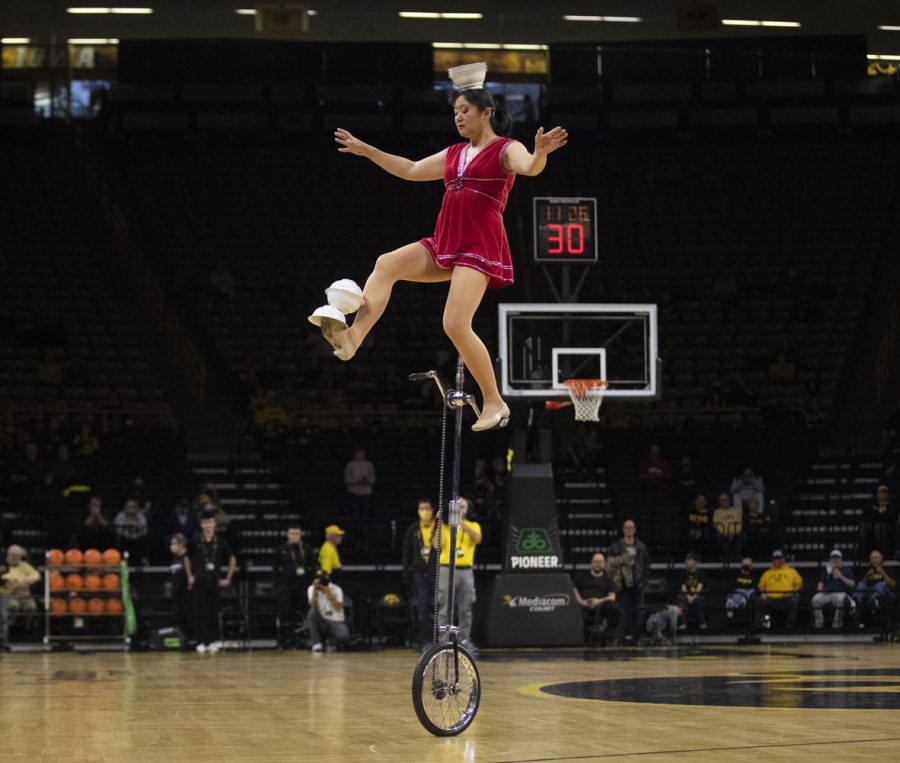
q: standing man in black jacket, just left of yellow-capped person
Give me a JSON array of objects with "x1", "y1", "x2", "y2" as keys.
[{"x1": 272, "y1": 522, "x2": 316, "y2": 649}]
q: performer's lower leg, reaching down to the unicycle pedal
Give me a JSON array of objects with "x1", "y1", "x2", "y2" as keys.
[{"x1": 444, "y1": 267, "x2": 503, "y2": 419}]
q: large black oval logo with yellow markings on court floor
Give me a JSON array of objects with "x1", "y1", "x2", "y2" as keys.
[{"x1": 540, "y1": 668, "x2": 900, "y2": 710}]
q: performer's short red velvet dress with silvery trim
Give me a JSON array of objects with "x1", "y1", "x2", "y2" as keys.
[{"x1": 421, "y1": 138, "x2": 516, "y2": 289}]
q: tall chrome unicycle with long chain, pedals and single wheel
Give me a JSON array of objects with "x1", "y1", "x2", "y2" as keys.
[{"x1": 409, "y1": 358, "x2": 492, "y2": 736}]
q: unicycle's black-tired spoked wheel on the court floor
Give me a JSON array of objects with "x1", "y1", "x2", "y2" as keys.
[{"x1": 412, "y1": 642, "x2": 481, "y2": 737}]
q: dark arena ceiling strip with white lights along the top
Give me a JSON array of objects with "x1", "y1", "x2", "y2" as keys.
[{"x1": 0, "y1": 0, "x2": 900, "y2": 54}]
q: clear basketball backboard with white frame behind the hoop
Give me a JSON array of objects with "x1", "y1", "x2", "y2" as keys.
[{"x1": 499, "y1": 303, "x2": 659, "y2": 399}]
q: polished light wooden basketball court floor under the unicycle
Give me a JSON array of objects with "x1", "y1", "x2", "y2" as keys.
[{"x1": 7, "y1": 644, "x2": 900, "y2": 763}]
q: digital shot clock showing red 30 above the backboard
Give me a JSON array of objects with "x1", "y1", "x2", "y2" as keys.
[{"x1": 534, "y1": 197, "x2": 597, "y2": 264}]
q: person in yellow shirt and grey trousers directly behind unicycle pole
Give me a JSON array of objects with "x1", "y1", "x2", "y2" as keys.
[{"x1": 432, "y1": 496, "x2": 481, "y2": 649}]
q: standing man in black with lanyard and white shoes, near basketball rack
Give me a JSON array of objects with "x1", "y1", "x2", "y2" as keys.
[{"x1": 184, "y1": 504, "x2": 237, "y2": 652}]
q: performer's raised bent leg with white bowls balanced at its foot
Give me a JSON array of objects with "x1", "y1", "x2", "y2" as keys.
[{"x1": 341, "y1": 242, "x2": 452, "y2": 352}]
